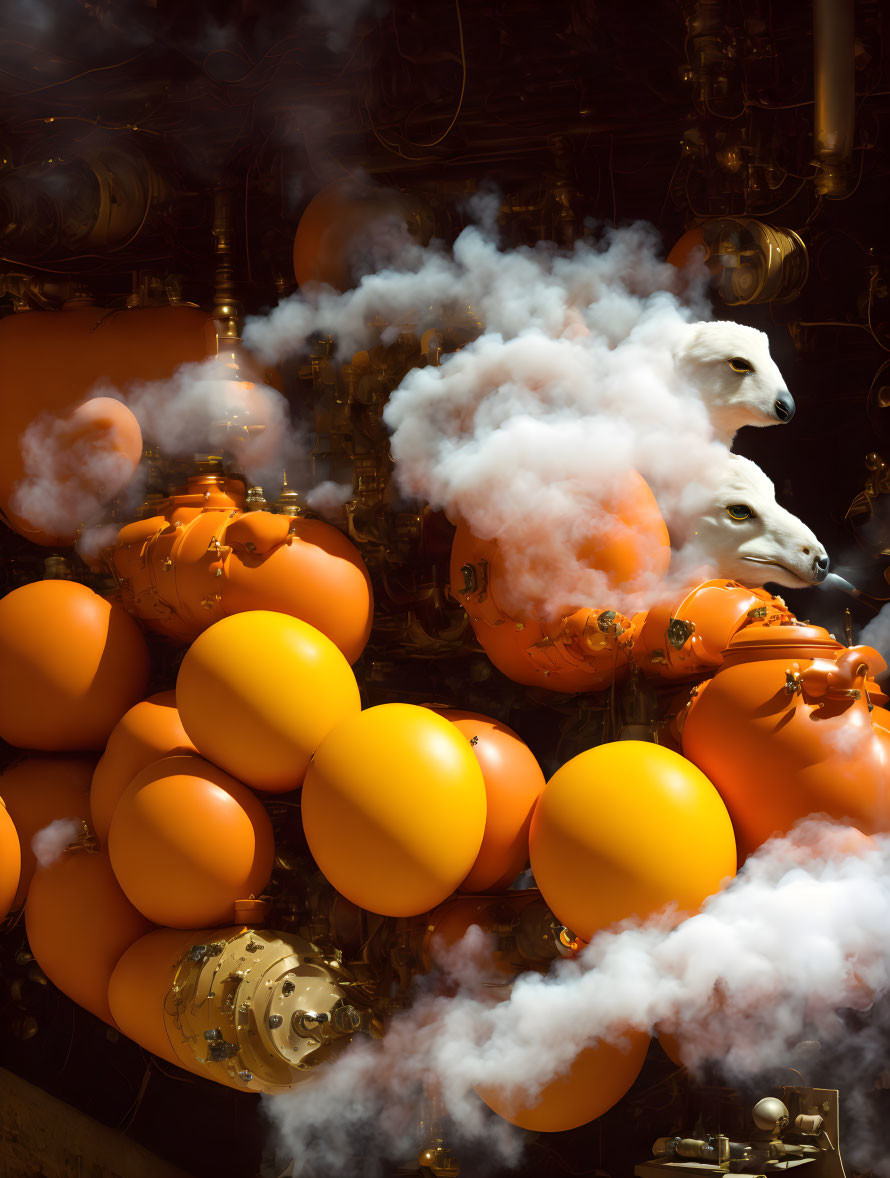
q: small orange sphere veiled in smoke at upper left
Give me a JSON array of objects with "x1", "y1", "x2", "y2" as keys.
[{"x1": 6, "y1": 397, "x2": 142, "y2": 544}]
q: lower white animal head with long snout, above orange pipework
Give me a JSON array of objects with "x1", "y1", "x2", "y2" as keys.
[{"x1": 690, "y1": 454, "x2": 829, "y2": 589}]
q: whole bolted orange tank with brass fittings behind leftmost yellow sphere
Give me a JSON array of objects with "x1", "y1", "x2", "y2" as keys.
[{"x1": 105, "y1": 475, "x2": 373, "y2": 662}]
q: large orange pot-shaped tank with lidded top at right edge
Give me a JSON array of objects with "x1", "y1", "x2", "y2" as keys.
[{"x1": 683, "y1": 624, "x2": 890, "y2": 858}]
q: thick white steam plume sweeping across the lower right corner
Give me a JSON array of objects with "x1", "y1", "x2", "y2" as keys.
[{"x1": 267, "y1": 820, "x2": 890, "y2": 1173}]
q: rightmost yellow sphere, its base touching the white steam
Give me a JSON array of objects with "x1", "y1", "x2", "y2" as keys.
[{"x1": 529, "y1": 741, "x2": 736, "y2": 940}]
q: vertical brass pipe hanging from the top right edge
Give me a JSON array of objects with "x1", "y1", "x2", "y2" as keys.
[{"x1": 812, "y1": 0, "x2": 856, "y2": 197}]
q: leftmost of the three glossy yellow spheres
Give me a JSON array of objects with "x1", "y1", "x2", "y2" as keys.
[{"x1": 177, "y1": 610, "x2": 361, "y2": 793}]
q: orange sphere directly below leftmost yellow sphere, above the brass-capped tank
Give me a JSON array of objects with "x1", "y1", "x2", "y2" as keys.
[{"x1": 108, "y1": 754, "x2": 274, "y2": 928}]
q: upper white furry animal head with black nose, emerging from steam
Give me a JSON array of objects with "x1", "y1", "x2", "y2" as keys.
[{"x1": 675, "y1": 320, "x2": 795, "y2": 445}]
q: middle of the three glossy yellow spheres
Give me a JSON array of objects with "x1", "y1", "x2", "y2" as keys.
[{"x1": 303, "y1": 703, "x2": 485, "y2": 916}]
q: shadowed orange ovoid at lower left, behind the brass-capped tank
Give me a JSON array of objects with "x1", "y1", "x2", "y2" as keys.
[{"x1": 25, "y1": 849, "x2": 152, "y2": 1023}]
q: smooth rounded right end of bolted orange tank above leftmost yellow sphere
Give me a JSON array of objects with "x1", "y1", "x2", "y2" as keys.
[{"x1": 226, "y1": 511, "x2": 374, "y2": 663}]
